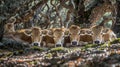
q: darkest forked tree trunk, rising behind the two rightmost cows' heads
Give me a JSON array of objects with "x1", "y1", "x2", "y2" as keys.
[{"x1": 74, "y1": 0, "x2": 93, "y2": 24}]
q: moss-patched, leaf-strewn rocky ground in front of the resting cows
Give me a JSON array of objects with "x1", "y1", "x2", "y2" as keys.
[{"x1": 0, "y1": 39, "x2": 120, "y2": 67}]
